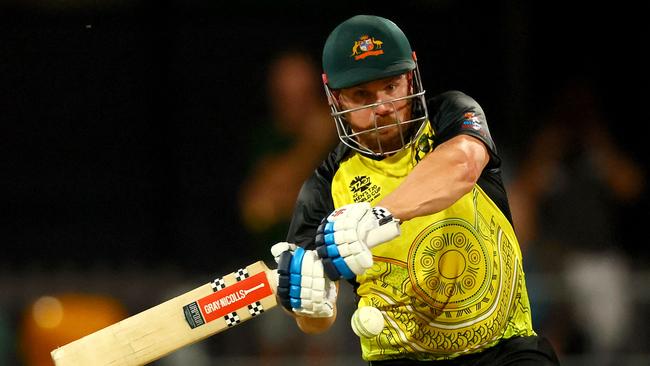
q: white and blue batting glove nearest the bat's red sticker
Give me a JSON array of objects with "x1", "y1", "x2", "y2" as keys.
[{"x1": 271, "y1": 242, "x2": 337, "y2": 318}]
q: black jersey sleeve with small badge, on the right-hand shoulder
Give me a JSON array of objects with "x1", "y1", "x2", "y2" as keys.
[{"x1": 429, "y1": 91, "x2": 501, "y2": 168}]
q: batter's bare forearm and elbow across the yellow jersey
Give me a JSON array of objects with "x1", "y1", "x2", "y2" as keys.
[{"x1": 378, "y1": 135, "x2": 490, "y2": 221}]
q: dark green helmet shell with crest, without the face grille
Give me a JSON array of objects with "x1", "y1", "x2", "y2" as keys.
[{"x1": 323, "y1": 15, "x2": 416, "y2": 89}]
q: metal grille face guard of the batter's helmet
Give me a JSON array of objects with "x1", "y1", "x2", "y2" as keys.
[{"x1": 323, "y1": 56, "x2": 428, "y2": 157}]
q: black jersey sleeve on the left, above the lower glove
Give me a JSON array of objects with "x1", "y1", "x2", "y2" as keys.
[{"x1": 287, "y1": 144, "x2": 349, "y2": 249}]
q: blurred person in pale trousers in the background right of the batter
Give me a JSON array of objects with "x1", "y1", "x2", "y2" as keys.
[{"x1": 508, "y1": 79, "x2": 646, "y2": 365}]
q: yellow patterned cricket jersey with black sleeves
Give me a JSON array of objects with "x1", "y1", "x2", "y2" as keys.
[{"x1": 288, "y1": 92, "x2": 535, "y2": 360}]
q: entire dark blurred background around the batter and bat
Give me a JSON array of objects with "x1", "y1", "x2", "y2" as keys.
[{"x1": 0, "y1": 0, "x2": 650, "y2": 366}]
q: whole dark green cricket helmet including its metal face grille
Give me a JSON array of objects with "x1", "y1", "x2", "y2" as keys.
[{"x1": 322, "y1": 15, "x2": 428, "y2": 156}]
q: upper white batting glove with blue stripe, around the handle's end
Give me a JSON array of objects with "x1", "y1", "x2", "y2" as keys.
[{"x1": 316, "y1": 202, "x2": 399, "y2": 281}]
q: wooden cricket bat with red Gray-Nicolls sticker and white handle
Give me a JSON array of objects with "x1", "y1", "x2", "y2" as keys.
[{"x1": 51, "y1": 221, "x2": 400, "y2": 366}]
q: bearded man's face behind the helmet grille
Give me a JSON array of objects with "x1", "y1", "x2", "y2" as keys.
[{"x1": 338, "y1": 74, "x2": 411, "y2": 152}]
